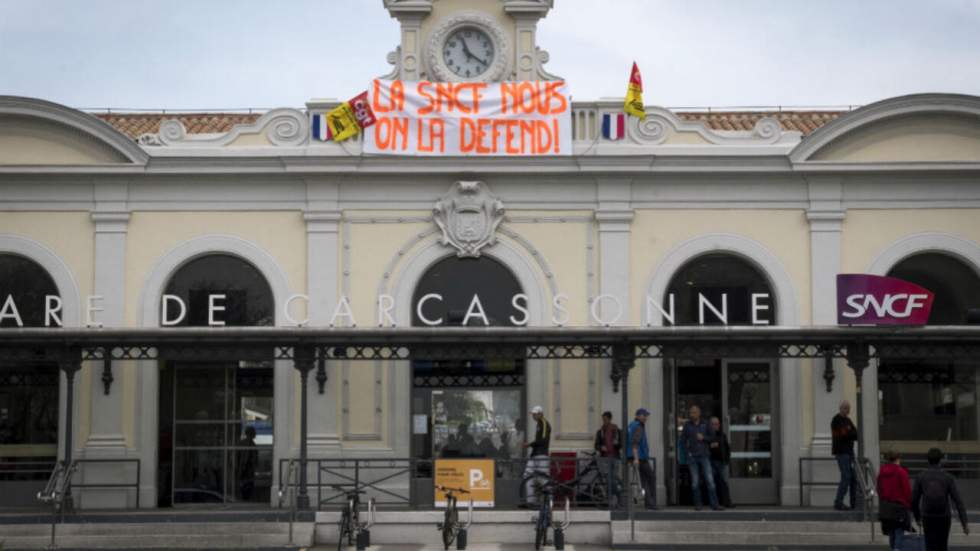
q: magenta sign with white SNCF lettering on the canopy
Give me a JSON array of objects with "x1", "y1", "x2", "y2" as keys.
[{"x1": 837, "y1": 274, "x2": 933, "y2": 325}]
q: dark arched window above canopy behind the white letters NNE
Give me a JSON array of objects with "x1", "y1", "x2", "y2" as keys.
[{"x1": 661, "y1": 253, "x2": 776, "y2": 325}]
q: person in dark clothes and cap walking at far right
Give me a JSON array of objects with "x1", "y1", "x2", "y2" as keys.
[{"x1": 912, "y1": 448, "x2": 970, "y2": 551}]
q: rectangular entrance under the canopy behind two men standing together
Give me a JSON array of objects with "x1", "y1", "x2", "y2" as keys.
[{"x1": 664, "y1": 360, "x2": 779, "y2": 505}]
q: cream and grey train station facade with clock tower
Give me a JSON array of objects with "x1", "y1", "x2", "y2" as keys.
[{"x1": 0, "y1": 0, "x2": 980, "y2": 507}]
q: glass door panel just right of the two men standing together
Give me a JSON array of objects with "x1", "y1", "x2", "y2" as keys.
[{"x1": 722, "y1": 360, "x2": 779, "y2": 504}]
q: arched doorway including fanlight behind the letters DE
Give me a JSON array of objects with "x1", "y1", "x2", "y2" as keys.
[{"x1": 157, "y1": 254, "x2": 275, "y2": 507}]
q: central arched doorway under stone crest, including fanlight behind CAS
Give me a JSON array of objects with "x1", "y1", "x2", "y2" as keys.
[{"x1": 411, "y1": 255, "x2": 526, "y2": 459}]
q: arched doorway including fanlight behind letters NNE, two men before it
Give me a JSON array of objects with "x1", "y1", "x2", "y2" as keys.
[{"x1": 661, "y1": 253, "x2": 780, "y2": 505}]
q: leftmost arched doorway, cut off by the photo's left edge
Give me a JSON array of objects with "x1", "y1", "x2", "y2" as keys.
[{"x1": 0, "y1": 253, "x2": 61, "y2": 507}]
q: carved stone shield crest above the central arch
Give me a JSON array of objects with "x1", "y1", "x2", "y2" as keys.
[{"x1": 432, "y1": 181, "x2": 504, "y2": 258}]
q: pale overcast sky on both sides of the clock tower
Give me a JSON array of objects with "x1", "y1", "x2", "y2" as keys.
[{"x1": 0, "y1": 0, "x2": 980, "y2": 109}]
